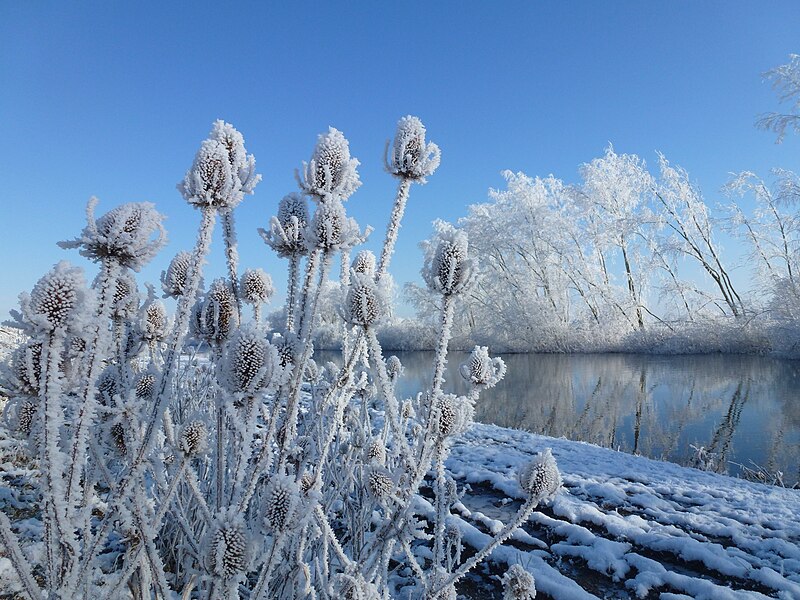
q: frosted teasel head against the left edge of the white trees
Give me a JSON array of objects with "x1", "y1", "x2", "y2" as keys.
[{"x1": 422, "y1": 223, "x2": 472, "y2": 296}]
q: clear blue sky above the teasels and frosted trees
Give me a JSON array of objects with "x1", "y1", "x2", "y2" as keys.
[{"x1": 0, "y1": 0, "x2": 800, "y2": 315}]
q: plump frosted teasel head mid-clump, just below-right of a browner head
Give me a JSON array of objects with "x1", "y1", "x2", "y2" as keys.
[{"x1": 219, "y1": 325, "x2": 280, "y2": 395}]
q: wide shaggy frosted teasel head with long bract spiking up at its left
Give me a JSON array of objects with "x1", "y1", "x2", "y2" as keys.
[{"x1": 59, "y1": 197, "x2": 167, "y2": 271}]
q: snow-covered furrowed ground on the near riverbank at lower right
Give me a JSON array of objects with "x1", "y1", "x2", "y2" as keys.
[{"x1": 447, "y1": 424, "x2": 800, "y2": 600}]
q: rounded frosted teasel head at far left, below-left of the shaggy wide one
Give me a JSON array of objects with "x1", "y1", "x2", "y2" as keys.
[{"x1": 21, "y1": 261, "x2": 87, "y2": 331}]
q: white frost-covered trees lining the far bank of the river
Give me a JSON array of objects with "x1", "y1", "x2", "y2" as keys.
[{"x1": 398, "y1": 56, "x2": 800, "y2": 353}]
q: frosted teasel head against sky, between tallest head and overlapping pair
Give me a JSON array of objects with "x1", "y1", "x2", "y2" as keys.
[{"x1": 296, "y1": 127, "x2": 361, "y2": 201}]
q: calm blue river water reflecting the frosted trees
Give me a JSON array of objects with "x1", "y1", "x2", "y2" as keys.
[{"x1": 320, "y1": 351, "x2": 800, "y2": 484}]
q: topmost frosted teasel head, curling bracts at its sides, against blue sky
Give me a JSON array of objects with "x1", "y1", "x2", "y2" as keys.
[{"x1": 384, "y1": 115, "x2": 441, "y2": 183}]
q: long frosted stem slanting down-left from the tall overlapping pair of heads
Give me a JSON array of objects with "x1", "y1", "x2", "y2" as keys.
[{"x1": 78, "y1": 207, "x2": 217, "y2": 582}]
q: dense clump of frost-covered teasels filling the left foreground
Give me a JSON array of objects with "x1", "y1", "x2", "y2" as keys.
[{"x1": 0, "y1": 117, "x2": 561, "y2": 600}]
